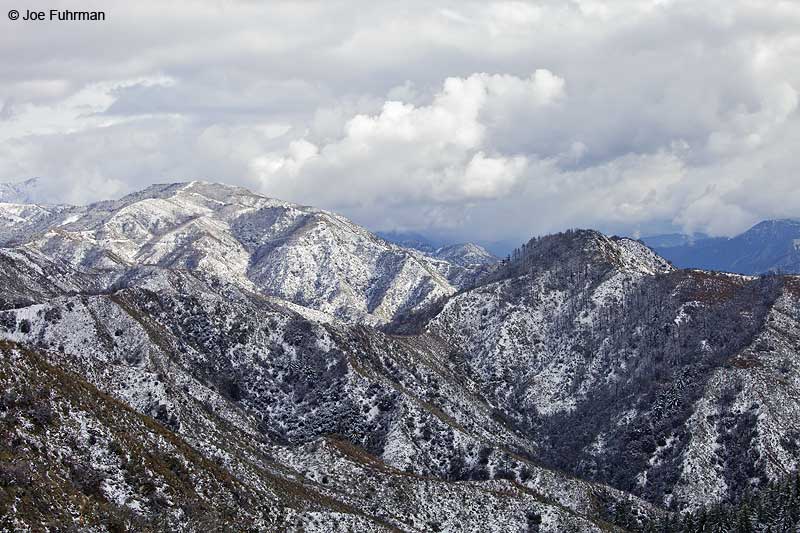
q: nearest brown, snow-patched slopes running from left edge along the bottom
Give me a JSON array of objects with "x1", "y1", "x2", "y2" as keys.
[{"x1": 0, "y1": 343, "x2": 620, "y2": 532}]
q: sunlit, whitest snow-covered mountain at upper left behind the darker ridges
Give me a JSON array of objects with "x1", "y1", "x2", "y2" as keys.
[{"x1": 9, "y1": 182, "x2": 484, "y2": 324}]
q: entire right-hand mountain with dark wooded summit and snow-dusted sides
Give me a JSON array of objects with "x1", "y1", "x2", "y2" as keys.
[{"x1": 427, "y1": 231, "x2": 800, "y2": 508}]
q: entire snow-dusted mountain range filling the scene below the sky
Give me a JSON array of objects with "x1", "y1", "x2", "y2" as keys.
[{"x1": 0, "y1": 182, "x2": 800, "y2": 532}]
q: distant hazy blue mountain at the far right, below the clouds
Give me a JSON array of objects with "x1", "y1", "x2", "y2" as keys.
[{"x1": 642, "y1": 219, "x2": 800, "y2": 274}]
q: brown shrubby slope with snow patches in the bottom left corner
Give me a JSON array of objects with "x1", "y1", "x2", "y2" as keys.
[{"x1": 0, "y1": 343, "x2": 285, "y2": 530}]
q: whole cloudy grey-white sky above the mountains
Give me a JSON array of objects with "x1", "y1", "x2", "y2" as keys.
[{"x1": 0, "y1": 0, "x2": 800, "y2": 240}]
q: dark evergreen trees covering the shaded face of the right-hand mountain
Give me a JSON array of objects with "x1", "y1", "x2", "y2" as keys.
[{"x1": 488, "y1": 256, "x2": 783, "y2": 503}]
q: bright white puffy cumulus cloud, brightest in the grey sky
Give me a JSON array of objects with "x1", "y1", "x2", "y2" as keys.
[{"x1": 254, "y1": 70, "x2": 564, "y2": 206}]
